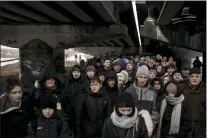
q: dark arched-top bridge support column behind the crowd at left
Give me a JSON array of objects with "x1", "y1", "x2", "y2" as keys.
[{"x1": 20, "y1": 39, "x2": 64, "y2": 94}]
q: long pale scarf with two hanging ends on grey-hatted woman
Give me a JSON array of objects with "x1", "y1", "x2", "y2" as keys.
[{"x1": 157, "y1": 94, "x2": 184, "y2": 138}]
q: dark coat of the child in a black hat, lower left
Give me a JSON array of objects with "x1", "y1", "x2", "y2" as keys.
[{"x1": 27, "y1": 114, "x2": 70, "y2": 138}]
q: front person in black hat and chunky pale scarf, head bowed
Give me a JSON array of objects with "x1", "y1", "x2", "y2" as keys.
[{"x1": 102, "y1": 92, "x2": 149, "y2": 138}]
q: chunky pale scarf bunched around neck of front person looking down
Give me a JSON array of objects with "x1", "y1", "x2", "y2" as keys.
[{"x1": 111, "y1": 108, "x2": 139, "y2": 138}]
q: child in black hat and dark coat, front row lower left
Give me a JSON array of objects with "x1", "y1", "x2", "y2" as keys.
[{"x1": 27, "y1": 96, "x2": 70, "y2": 138}]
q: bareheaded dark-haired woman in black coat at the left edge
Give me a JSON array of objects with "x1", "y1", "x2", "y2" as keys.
[{"x1": 0, "y1": 77, "x2": 34, "y2": 138}]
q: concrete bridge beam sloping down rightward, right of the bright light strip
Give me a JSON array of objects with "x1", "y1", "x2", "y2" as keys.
[{"x1": 140, "y1": 26, "x2": 206, "y2": 52}]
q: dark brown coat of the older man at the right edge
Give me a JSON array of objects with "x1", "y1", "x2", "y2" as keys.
[{"x1": 183, "y1": 82, "x2": 206, "y2": 135}]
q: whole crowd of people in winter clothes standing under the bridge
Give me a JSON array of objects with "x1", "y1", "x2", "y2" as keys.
[{"x1": 0, "y1": 53, "x2": 206, "y2": 138}]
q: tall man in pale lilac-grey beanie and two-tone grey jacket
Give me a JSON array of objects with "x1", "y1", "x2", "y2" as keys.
[{"x1": 126, "y1": 65, "x2": 158, "y2": 130}]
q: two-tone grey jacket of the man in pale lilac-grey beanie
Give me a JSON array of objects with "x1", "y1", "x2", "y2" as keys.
[{"x1": 125, "y1": 81, "x2": 159, "y2": 128}]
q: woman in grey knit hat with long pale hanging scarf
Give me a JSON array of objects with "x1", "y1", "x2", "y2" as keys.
[{"x1": 157, "y1": 81, "x2": 193, "y2": 138}]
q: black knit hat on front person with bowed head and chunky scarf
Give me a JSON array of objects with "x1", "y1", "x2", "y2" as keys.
[{"x1": 116, "y1": 92, "x2": 135, "y2": 108}]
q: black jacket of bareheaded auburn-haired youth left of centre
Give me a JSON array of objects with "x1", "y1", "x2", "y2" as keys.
[{"x1": 81, "y1": 88, "x2": 112, "y2": 137}]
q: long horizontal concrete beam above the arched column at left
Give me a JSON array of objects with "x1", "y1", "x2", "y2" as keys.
[{"x1": 0, "y1": 25, "x2": 133, "y2": 48}]
